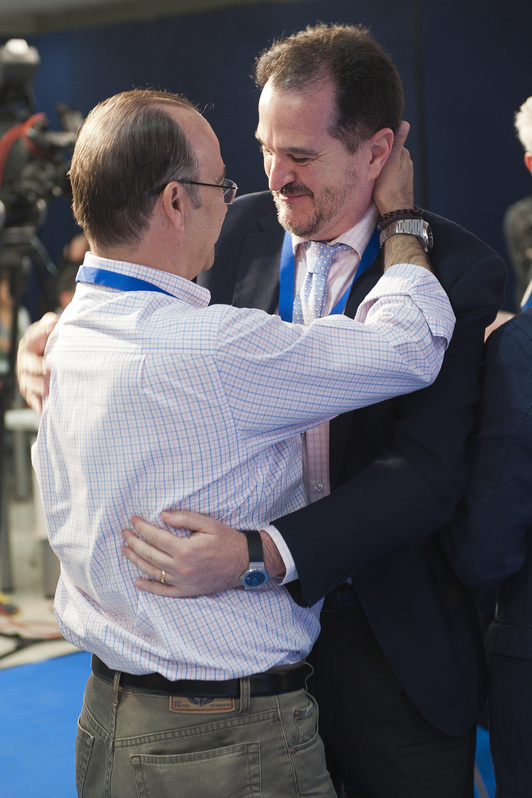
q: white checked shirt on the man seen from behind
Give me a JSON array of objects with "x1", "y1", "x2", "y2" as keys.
[{"x1": 33, "y1": 254, "x2": 454, "y2": 679}]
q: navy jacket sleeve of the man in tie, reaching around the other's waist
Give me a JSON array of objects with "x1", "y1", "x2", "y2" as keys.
[{"x1": 273, "y1": 235, "x2": 505, "y2": 604}]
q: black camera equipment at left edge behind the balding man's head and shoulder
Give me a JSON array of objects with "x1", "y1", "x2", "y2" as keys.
[{"x1": 0, "y1": 39, "x2": 82, "y2": 590}]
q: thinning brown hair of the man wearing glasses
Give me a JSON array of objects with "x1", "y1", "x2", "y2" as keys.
[{"x1": 70, "y1": 89, "x2": 202, "y2": 246}]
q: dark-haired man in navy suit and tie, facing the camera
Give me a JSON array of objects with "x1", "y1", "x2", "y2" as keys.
[{"x1": 17, "y1": 21, "x2": 505, "y2": 798}]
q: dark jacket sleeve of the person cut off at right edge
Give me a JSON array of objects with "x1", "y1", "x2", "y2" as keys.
[{"x1": 442, "y1": 311, "x2": 532, "y2": 587}]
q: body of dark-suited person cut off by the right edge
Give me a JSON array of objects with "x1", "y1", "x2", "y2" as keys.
[{"x1": 444, "y1": 310, "x2": 532, "y2": 798}]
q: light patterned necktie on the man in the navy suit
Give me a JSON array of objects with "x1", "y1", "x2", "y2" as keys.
[{"x1": 292, "y1": 241, "x2": 350, "y2": 324}]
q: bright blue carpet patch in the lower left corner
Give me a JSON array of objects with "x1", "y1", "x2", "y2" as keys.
[{"x1": 0, "y1": 653, "x2": 90, "y2": 798}]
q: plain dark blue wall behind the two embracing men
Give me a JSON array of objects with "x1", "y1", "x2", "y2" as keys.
[{"x1": 4, "y1": 0, "x2": 532, "y2": 309}]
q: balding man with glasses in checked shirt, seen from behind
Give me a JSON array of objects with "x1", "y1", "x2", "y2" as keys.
[{"x1": 33, "y1": 91, "x2": 455, "y2": 798}]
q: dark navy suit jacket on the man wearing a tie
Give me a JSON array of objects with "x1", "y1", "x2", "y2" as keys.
[{"x1": 199, "y1": 192, "x2": 505, "y2": 734}]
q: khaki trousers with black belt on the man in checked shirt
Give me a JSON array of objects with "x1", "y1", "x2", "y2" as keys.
[{"x1": 76, "y1": 674, "x2": 336, "y2": 798}]
